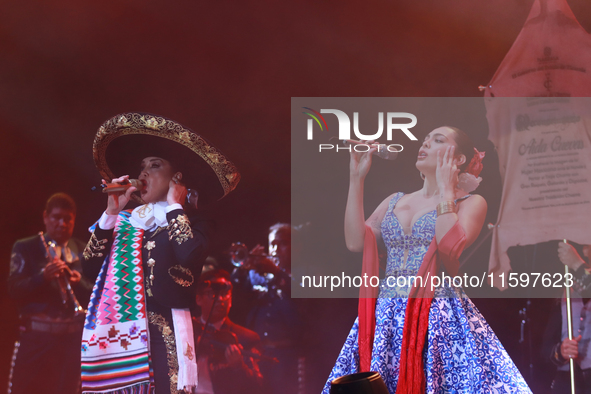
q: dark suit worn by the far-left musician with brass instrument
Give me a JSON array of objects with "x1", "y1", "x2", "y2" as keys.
[{"x1": 8, "y1": 235, "x2": 92, "y2": 394}]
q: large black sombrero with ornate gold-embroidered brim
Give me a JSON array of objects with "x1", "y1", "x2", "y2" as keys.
[{"x1": 92, "y1": 113, "x2": 240, "y2": 205}]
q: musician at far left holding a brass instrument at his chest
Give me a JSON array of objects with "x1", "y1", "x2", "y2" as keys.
[{"x1": 8, "y1": 193, "x2": 92, "y2": 394}]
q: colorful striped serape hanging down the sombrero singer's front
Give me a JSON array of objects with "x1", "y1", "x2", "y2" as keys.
[{"x1": 82, "y1": 211, "x2": 151, "y2": 394}]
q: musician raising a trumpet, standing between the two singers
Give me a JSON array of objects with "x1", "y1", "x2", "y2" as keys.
[{"x1": 232, "y1": 223, "x2": 307, "y2": 394}]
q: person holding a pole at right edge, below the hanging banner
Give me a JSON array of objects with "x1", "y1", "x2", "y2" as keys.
[{"x1": 544, "y1": 242, "x2": 591, "y2": 394}]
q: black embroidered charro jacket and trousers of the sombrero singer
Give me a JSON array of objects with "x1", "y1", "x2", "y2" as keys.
[{"x1": 83, "y1": 209, "x2": 212, "y2": 394}]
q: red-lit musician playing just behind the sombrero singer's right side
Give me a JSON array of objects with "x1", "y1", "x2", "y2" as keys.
[{"x1": 193, "y1": 270, "x2": 263, "y2": 394}]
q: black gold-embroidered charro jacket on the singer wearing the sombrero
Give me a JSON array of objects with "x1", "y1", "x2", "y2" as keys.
[{"x1": 83, "y1": 209, "x2": 213, "y2": 309}]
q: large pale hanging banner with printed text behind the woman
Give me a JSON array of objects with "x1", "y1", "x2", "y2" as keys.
[{"x1": 485, "y1": 0, "x2": 591, "y2": 285}]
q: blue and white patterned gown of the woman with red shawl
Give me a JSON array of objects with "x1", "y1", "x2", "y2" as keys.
[{"x1": 323, "y1": 193, "x2": 531, "y2": 394}]
